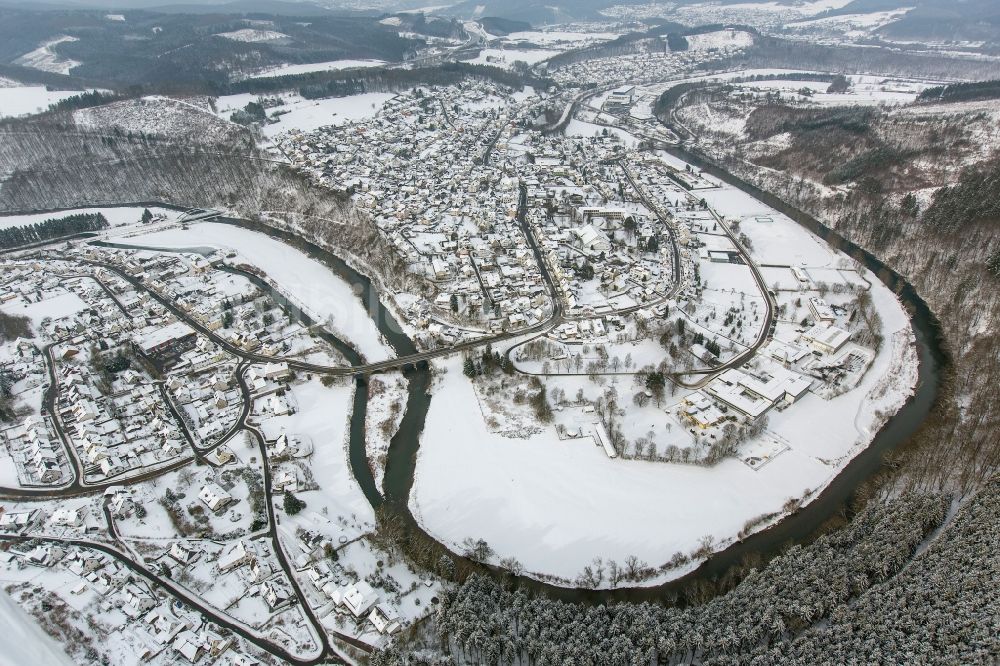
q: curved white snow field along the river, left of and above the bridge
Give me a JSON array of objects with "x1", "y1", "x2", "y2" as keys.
[{"x1": 128, "y1": 222, "x2": 392, "y2": 361}]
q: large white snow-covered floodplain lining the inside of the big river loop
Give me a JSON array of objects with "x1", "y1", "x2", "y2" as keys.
[{"x1": 411, "y1": 154, "x2": 916, "y2": 583}]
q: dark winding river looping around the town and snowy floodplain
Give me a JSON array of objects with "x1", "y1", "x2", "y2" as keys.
[{"x1": 78, "y1": 179, "x2": 948, "y2": 603}]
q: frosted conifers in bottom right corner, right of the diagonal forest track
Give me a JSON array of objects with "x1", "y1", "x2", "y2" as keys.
[{"x1": 756, "y1": 481, "x2": 1000, "y2": 664}]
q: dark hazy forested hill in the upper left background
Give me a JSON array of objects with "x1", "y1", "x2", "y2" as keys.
[{"x1": 0, "y1": 6, "x2": 423, "y2": 92}]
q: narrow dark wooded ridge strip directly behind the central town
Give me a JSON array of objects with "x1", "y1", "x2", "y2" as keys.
[{"x1": 225, "y1": 62, "x2": 551, "y2": 99}]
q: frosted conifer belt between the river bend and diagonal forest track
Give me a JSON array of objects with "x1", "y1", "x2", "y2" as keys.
[{"x1": 408, "y1": 494, "x2": 952, "y2": 664}]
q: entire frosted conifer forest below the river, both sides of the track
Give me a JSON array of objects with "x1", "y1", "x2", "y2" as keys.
[{"x1": 388, "y1": 483, "x2": 1000, "y2": 666}]
